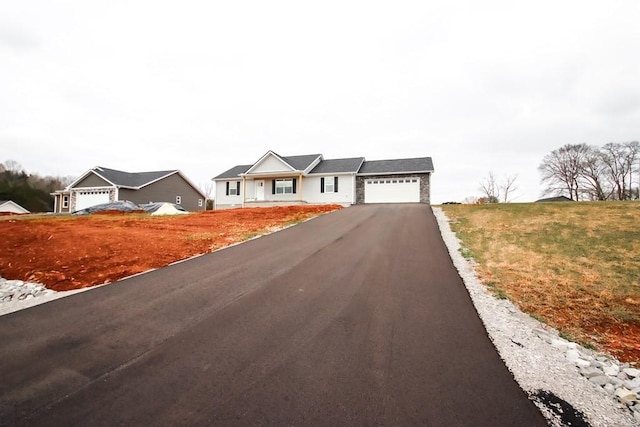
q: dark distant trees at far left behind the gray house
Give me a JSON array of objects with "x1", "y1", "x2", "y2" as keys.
[{"x1": 0, "y1": 160, "x2": 72, "y2": 212}]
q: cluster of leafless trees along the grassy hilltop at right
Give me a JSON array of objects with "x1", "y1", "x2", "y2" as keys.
[{"x1": 538, "y1": 141, "x2": 640, "y2": 200}]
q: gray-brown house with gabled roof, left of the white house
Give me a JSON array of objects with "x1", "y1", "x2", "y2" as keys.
[{"x1": 52, "y1": 166, "x2": 206, "y2": 213}]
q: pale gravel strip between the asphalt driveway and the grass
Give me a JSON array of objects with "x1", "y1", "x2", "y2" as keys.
[{"x1": 432, "y1": 207, "x2": 640, "y2": 426}]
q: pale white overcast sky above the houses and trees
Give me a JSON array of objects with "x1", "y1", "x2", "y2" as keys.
[{"x1": 0, "y1": 0, "x2": 640, "y2": 203}]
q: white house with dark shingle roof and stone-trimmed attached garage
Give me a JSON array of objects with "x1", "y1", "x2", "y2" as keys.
[{"x1": 213, "y1": 151, "x2": 434, "y2": 209}]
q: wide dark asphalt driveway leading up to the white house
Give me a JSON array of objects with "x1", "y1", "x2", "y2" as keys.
[{"x1": 0, "y1": 205, "x2": 546, "y2": 426}]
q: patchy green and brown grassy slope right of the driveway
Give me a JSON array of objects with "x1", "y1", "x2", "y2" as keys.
[{"x1": 442, "y1": 202, "x2": 640, "y2": 361}]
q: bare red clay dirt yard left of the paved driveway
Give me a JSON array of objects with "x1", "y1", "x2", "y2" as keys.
[{"x1": 0, "y1": 205, "x2": 340, "y2": 291}]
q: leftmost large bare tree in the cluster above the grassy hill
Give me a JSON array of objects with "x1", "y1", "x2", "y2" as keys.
[{"x1": 538, "y1": 144, "x2": 589, "y2": 200}]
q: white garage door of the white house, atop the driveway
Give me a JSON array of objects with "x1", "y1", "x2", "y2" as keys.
[{"x1": 364, "y1": 178, "x2": 420, "y2": 203}]
